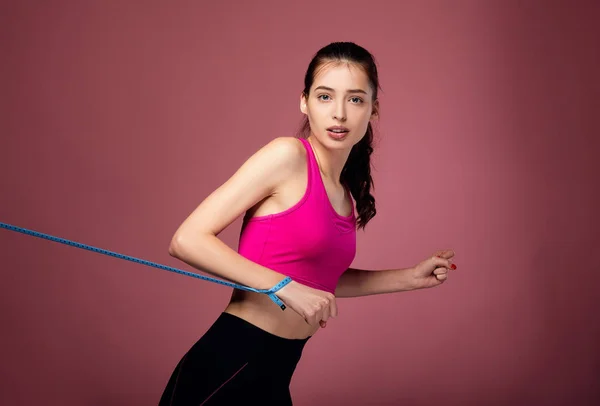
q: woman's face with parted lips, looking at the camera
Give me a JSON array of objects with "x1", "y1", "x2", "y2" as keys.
[{"x1": 300, "y1": 62, "x2": 378, "y2": 149}]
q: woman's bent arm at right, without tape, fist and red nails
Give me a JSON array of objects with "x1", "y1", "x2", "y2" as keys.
[{"x1": 335, "y1": 250, "x2": 456, "y2": 298}]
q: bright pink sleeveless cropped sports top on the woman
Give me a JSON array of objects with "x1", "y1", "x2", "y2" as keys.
[{"x1": 238, "y1": 139, "x2": 356, "y2": 293}]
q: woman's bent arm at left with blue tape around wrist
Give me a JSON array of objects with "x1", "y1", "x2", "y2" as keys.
[{"x1": 169, "y1": 137, "x2": 337, "y2": 325}]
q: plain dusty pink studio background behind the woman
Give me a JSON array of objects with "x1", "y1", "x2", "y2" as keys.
[{"x1": 0, "y1": 0, "x2": 600, "y2": 406}]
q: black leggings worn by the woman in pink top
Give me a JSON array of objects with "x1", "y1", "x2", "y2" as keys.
[{"x1": 159, "y1": 313, "x2": 308, "y2": 406}]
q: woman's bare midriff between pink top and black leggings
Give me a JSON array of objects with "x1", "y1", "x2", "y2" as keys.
[{"x1": 224, "y1": 289, "x2": 320, "y2": 340}]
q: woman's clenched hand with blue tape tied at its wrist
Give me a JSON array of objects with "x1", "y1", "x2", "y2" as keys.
[{"x1": 275, "y1": 281, "x2": 337, "y2": 327}]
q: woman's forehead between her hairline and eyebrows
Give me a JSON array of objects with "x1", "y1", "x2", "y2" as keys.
[{"x1": 312, "y1": 62, "x2": 371, "y2": 94}]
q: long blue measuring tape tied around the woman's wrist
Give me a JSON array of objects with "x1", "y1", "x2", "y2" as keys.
[{"x1": 0, "y1": 222, "x2": 292, "y2": 310}]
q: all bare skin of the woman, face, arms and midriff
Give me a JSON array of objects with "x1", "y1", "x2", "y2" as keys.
[{"x1": 169, "y1": 63, "x2": 454, "y2": 339}]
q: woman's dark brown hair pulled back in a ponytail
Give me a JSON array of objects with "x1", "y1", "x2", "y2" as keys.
[{"x1": 298, "y1": 42, "x2": 380, "y2": 230}]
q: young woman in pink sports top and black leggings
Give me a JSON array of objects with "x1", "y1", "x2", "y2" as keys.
[{"x1": 160, "y1": 42, "x2": 455, "y2": 406}]
